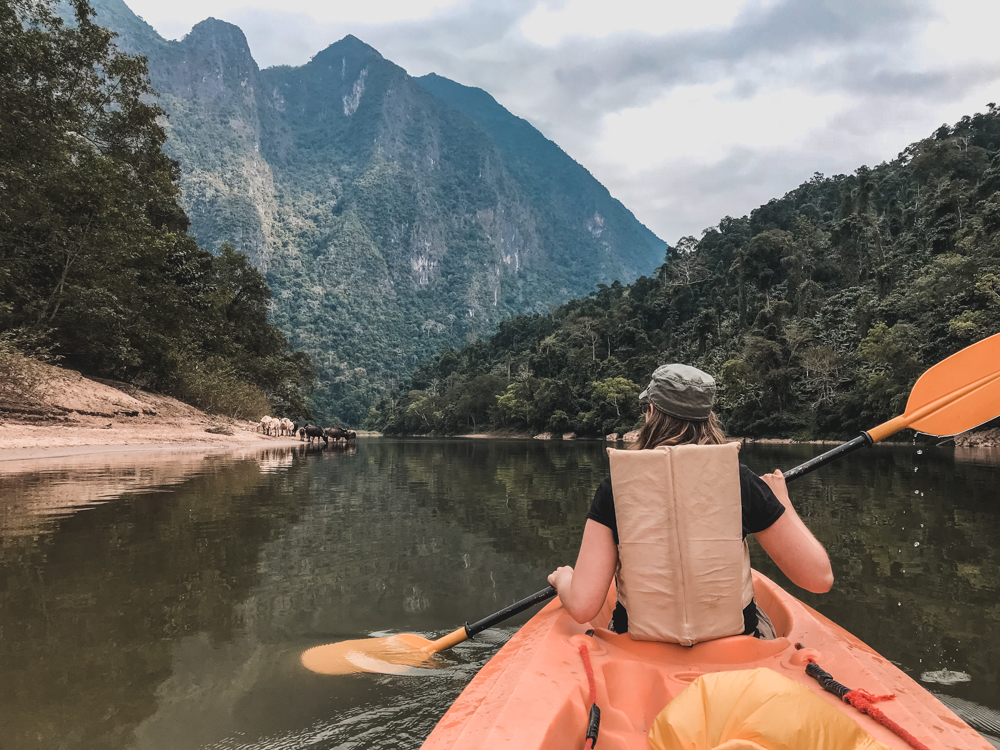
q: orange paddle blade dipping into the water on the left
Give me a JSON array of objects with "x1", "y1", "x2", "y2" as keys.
[{"x1": 302, "y1": 633, "x2": 443, "y2": 675}]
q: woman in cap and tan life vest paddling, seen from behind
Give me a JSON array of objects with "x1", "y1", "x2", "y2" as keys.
[{"x1": 549, "y1": 364, "x2": 833, "y2": 645}]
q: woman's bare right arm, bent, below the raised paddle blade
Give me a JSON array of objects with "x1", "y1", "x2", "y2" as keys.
[{"x1": 754, "y1": 469, "x2": 833, "y2": 594}]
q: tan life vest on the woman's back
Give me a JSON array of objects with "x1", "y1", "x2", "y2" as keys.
[{"x1": 608, "y1": 443, "x2": 753, "y2": 646}]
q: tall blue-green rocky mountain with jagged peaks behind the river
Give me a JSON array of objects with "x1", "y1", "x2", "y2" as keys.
[{"x1": 84, "y1": 0, "x2": 665, "y2": 424}]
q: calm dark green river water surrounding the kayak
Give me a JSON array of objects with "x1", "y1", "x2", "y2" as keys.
[{"x1": 0, "y1": 439, "x2": 1000, "y2": 750}]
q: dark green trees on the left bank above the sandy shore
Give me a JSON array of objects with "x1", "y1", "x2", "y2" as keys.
[{"x1": 0, "y1": 0, "x2": 314, "y2": 424}]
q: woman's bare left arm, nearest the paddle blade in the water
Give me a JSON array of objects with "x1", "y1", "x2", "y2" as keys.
[{"x1": 549, "y1": 518, "x2": 618, "y2": 624}]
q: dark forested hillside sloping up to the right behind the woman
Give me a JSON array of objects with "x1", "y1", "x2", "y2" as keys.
[{"x1": 368, "y1": 113, "x2": 1000, "y2": 438}]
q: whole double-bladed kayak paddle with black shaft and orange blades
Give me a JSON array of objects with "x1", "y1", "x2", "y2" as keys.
[{"x1": 302, "y1": 334, "x2": 1000, "y2": 674}]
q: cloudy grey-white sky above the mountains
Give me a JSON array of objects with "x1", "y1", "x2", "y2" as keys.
[{"x1": 126, "y1": 0, "x2": 1000, "y2": 242}]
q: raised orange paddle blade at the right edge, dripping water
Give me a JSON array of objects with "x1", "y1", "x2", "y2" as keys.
[{"x1": 868, "y1": 334, "x2": 1000, "y2": 442}]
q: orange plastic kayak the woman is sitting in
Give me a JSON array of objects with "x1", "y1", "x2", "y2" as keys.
[{"x1": 423, "y1": 571, "x2": 993, "y2": 750}]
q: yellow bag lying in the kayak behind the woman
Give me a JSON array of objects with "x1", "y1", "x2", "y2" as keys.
[{"x1": 649, "y1": 667, "x2": 888, "y2": 750}]
